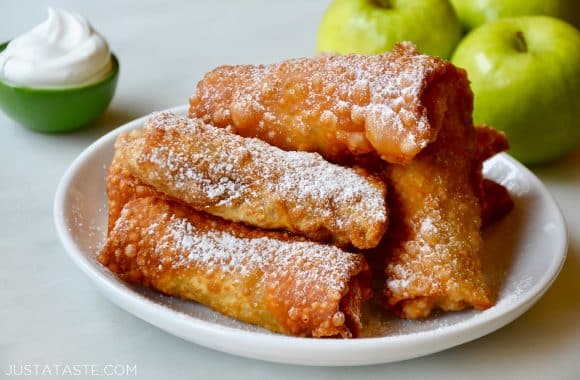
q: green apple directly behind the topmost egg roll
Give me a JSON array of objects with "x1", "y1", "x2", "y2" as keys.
[{"x1": 317, "y1": 0, "x2": 461, "y2": 58}]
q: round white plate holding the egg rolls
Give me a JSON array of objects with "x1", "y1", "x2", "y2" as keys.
[{"x1": 54, "y1": 106, "x2": 567, "y2": 366}]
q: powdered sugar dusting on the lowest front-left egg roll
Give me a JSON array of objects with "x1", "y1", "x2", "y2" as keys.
[{"x1": 146, "y1": 213, "x2": 360, "y2": 293}]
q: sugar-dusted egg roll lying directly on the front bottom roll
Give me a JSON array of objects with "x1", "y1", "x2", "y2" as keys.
[{"x1": 117, "y1": 113, "x2": 387, "y2": 248}]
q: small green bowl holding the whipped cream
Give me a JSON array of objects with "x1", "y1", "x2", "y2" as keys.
[{"x1": 0, "y1": 42, "x2": 119, "y2": 133}]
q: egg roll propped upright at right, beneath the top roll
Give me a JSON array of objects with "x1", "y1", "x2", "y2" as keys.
[{"x1": 385, "y1": 78, "x2": 492, "y2": 319}]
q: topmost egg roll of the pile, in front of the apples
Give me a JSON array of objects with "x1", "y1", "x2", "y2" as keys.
[{"x1": 189, "y1": 43, "x2": 469, "y2": 163}]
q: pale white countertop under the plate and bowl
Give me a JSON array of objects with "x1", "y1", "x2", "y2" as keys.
[{"x1": 0, "y1": 0, "x2": 580, "y2": 380}]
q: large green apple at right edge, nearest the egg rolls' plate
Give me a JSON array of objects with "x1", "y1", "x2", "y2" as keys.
[{"x1": 452, "y1": 16, "x2": 580, "y2": 164}]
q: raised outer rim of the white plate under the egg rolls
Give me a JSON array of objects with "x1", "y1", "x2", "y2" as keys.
[{"x1": 53, "y1": 105, "x2": 568, "y2": 366}]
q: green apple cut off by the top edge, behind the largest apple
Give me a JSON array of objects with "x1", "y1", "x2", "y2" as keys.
[{"x1": 451, "y1": 0, "x2": 580, "y2": 30}]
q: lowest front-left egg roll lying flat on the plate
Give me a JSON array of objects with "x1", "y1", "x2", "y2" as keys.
[{"x1": 98, "y1": 197, "x2": 372, "y2": 338}]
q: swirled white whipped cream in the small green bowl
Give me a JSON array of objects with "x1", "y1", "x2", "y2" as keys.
[{"x1": 0, "y1": 7, "x2": 112, "y2": 88}]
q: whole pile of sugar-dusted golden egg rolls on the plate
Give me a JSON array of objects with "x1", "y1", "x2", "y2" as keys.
[{"x1": 99, "y1": 43, "x2": 512, "y2": 337}]
